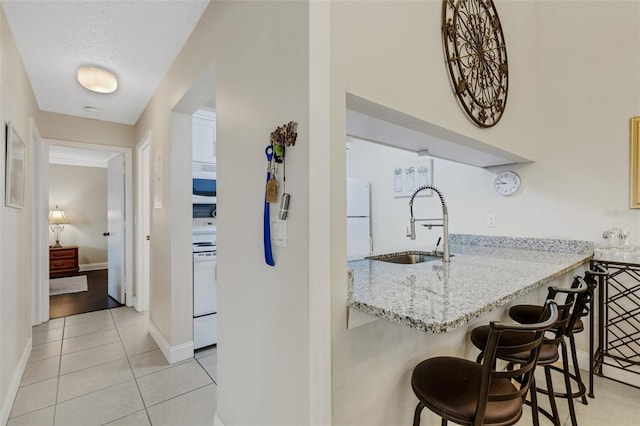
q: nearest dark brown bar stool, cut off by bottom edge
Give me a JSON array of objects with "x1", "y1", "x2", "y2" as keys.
[{"x1": 411, "y1": 300, "x2": 559, "y2": 426}]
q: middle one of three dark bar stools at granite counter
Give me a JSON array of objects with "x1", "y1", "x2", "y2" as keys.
[{"x1": 471, "y1": 277, "x2": 589, "y2": 426}]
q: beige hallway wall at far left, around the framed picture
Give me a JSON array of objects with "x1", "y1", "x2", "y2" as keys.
[{"x1": 0, "y1": 4, "x2": 38, "y2": 423}]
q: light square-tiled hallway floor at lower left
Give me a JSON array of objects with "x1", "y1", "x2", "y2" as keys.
[{"x1": 7, "y1": 307, "x2": 217, "y2": 426}]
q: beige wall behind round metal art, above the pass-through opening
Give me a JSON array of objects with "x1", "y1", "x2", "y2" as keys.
[{"x1": 331, "y1": 0, "x2": 536, "y2": 159}]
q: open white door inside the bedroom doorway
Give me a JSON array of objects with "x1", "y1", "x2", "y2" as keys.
[{"x1": 107, "y1": 154, "x2": 125, "y2": 304}]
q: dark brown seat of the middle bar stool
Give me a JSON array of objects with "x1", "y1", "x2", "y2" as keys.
[{"x1": 471, "y1": 321, "x2": 560, "y2": 365}]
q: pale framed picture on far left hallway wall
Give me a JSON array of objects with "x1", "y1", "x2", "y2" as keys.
[{"x1": 5, "y1": 121, "x2": 27, "y2": 209}]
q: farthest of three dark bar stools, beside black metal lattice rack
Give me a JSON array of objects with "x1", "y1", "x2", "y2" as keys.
[{"x1": 509, "y1": 263, "x2": 609, "y2": 405}]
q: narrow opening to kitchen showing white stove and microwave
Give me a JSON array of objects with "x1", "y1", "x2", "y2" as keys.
[{"x1": 171, "y1": 63, "x2": 219, "y2": 356}]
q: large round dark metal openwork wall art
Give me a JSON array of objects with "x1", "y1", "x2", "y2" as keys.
[{"x1": 442, "y1": 0, "x2": 509, "y2": 127}]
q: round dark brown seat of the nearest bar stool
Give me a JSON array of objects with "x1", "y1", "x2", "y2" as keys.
[{"x1": 411, "y1": 358, "x2": 522, "y2": 424}]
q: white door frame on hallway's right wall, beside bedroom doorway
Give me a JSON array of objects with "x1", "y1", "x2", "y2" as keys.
[{"x1": 134, "y1": 130, "x2": 151, "y2": 312}]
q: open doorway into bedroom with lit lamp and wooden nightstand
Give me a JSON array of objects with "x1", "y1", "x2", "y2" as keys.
[{"x1": 35, "y1": 140, "x2": 133, "y2": 322}]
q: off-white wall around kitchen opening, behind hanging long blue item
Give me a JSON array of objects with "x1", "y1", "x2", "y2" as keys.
[{"x1": 136, "y1": 1, "x2": 309, "y2": 426}]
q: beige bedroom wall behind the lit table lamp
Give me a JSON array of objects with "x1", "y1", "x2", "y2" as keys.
[{"x1": 49, "y1": 164, "x2": 108, "y2": 269}]
